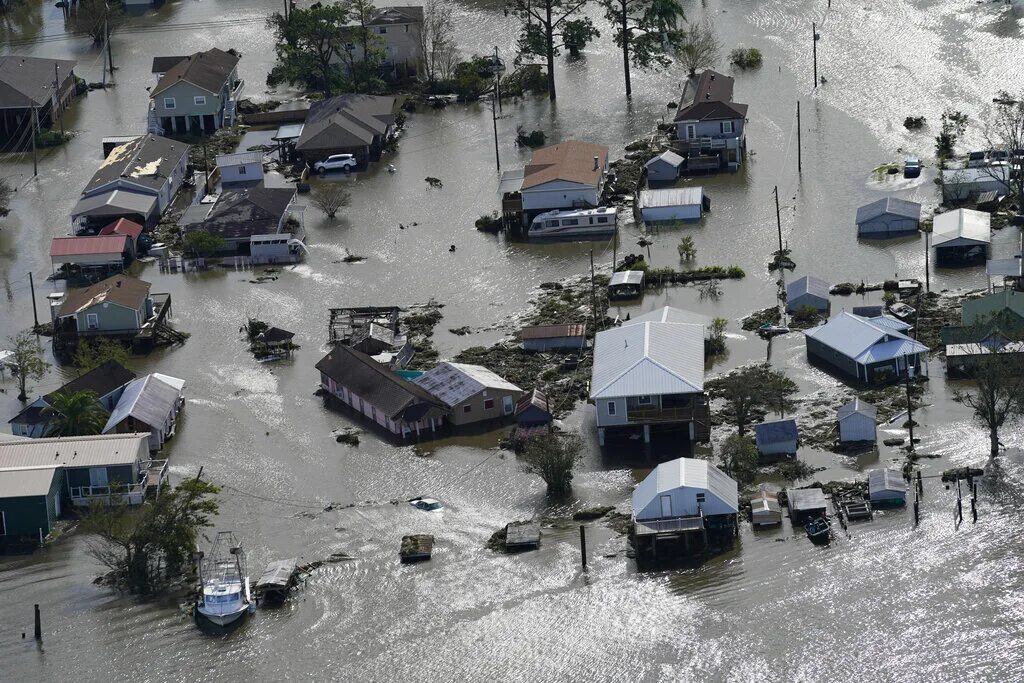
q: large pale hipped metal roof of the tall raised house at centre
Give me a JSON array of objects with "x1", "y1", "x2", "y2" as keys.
[{"x1": 590, "y1": 323, "x2": 705, "y2": 398}]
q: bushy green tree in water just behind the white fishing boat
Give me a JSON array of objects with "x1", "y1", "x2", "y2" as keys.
[{"x1": 82, "y1": 478, "x2": 220, "y2": 593}]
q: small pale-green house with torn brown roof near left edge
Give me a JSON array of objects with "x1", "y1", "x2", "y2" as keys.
[{"x1": 50, "y1": 274, "x2": 156, "y2": 337}]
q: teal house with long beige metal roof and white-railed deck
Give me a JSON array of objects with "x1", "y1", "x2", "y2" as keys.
[{"x1": 0, "y1": 434, "x2": 160, "y2": 508}]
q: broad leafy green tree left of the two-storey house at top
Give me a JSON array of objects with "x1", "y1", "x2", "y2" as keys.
[{"x1": 267, "y1": 3, "x2": 349, "y2": 97}]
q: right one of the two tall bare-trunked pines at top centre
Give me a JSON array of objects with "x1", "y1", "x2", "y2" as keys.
[{"x1": 599, "y1": 0, "x2": 686, "y2": 97}]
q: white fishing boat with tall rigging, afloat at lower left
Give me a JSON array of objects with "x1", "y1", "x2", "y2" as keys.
[{"x1": 196, "y1": 531, "x2": 256, "y2": 626}]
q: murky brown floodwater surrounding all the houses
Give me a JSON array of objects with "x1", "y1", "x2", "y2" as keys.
[{"x1": 0, "y1": 0, "x2": 1024, "y2": 681}]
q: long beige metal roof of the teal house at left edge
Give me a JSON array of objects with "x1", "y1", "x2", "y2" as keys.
[{"x1": 0, "y1": 433, "x2": 150, "y2": 468}]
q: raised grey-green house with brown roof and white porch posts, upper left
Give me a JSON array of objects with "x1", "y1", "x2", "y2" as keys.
[{"x1": 148, "y1": 47, "x2": 245, "y2": 135}]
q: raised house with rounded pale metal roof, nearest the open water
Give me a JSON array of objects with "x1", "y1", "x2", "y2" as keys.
[{"x1": 633, "y1": 458, "x2": 739, "y2": 556}]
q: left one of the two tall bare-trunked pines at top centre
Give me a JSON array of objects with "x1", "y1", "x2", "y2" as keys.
[{"x1": 512, "y1": 0, "x2": 601, "y2": 100}]
